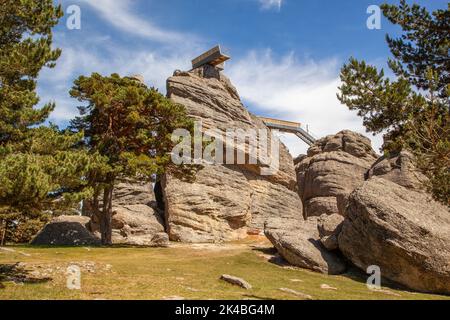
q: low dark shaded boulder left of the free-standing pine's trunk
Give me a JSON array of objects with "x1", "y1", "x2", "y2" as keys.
[{"x1": 31, "y1": 216, "x2": 100, "y2": 246}]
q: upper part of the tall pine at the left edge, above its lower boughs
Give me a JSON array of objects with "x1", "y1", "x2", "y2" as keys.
[{"x1": 0, "y1": 0, "x2": 63, "y2": 144}]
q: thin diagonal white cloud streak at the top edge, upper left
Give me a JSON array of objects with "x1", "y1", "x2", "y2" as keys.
[{"x1": 73, "y1": 0, "x2": 196, "y2": 43}]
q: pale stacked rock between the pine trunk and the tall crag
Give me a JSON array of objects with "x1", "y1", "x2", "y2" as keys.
[{"x1": 89, "y1": 181, "x2": 169, "y2": 246}]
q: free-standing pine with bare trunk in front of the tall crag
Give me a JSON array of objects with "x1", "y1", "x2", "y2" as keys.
[{"x1": 70, "y1": 73, "x2": 193, "y2": 245}]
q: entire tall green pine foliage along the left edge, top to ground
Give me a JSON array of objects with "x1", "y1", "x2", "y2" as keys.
[{"x1": 0, "y1": 0, "x2": 101, "y2": 244}]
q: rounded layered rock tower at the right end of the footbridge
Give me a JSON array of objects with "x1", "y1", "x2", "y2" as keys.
[{"x1": 296, "y1": 130, "x2": 377, "y2": 217}]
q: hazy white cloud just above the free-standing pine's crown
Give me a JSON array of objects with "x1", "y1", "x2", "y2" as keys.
[{"x1": 38, "y1": 33, "x2": 198, "y2": 124}]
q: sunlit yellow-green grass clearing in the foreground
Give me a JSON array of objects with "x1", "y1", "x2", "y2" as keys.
[{"x1": 0, "y1": 240, "x2": 450, "y2": 300}]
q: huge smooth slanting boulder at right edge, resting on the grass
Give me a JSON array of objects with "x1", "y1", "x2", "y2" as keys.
[{"x1": 339, "y1": 177, "x2": 450, "y2": 294}]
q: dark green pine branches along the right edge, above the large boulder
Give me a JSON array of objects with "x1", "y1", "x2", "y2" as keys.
[{"x1": 338, "y1": 0, "x2": 450, "y2": 205}]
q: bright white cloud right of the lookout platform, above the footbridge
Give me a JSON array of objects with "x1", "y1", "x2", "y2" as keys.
[{"x1": 227, "y1": 50, "x2": 382, "y2": 155}]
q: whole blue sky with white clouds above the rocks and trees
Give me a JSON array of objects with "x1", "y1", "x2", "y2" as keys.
[{"x1": 38, "y1": 0, "x2": 447, "y2": 156}]
